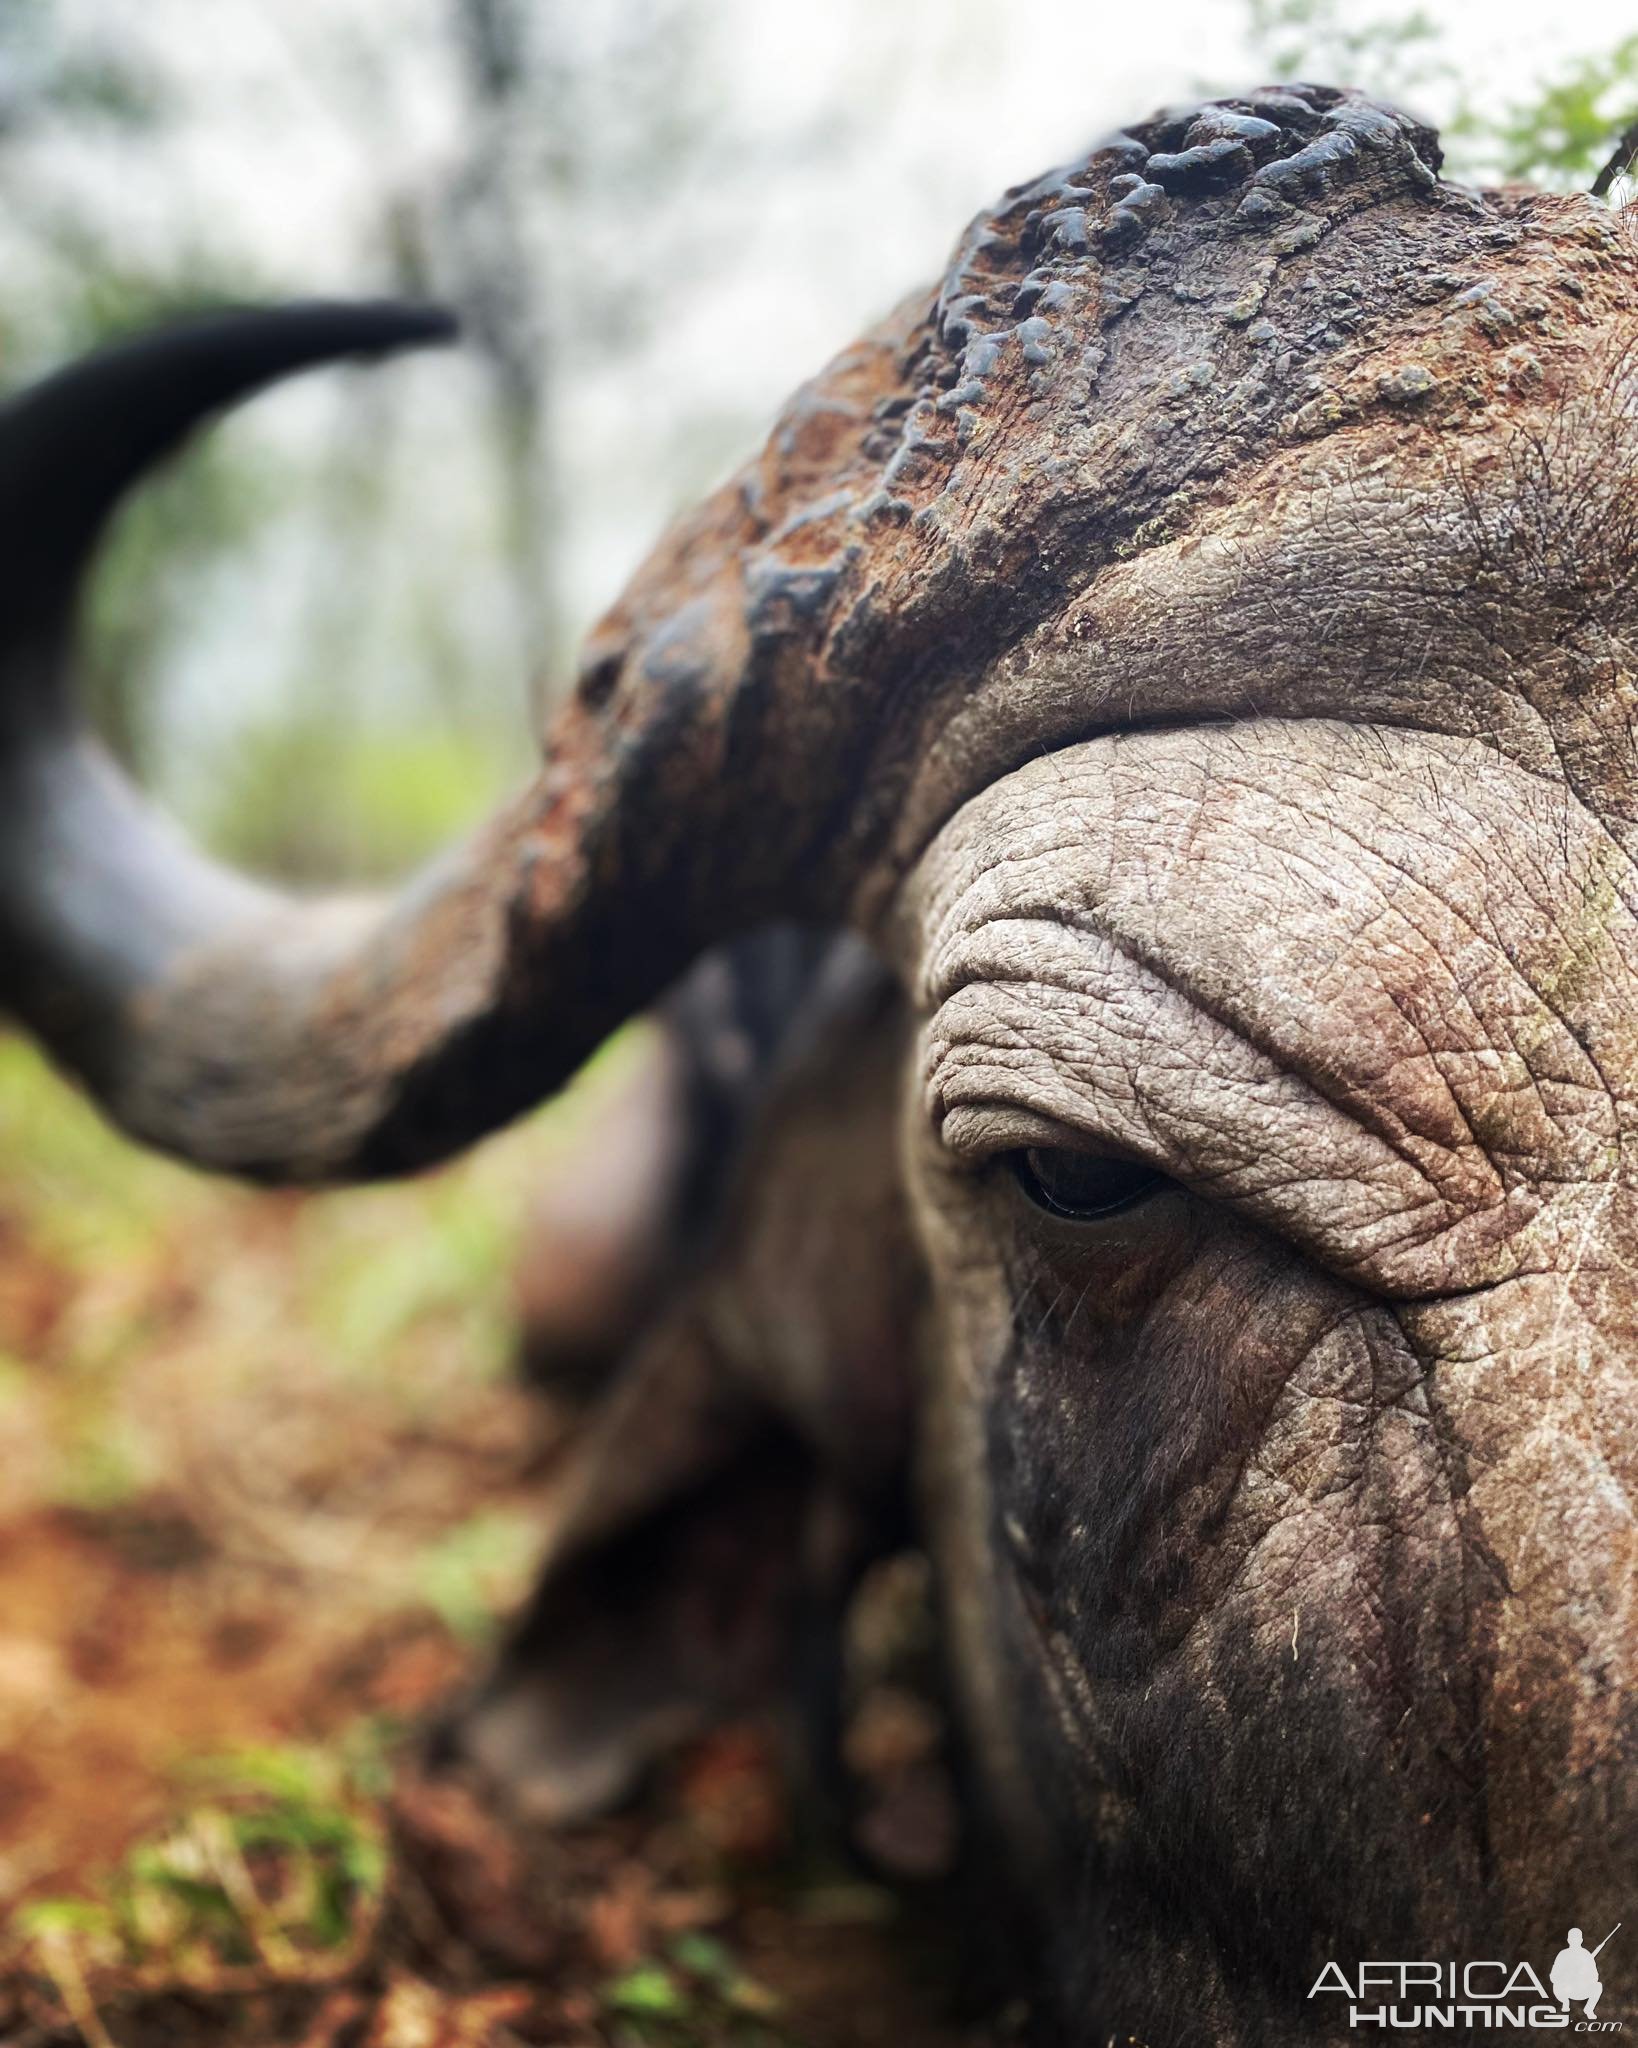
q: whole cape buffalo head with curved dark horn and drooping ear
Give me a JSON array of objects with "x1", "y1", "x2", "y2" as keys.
[{"x1": 0, "y1": 86, "x2": 1638, "y2": 2044}]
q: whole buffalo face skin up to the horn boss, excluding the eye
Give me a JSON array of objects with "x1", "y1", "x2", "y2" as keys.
[{"x1": 501, "y1": 188, "x2": 1638, "y2": 2042}]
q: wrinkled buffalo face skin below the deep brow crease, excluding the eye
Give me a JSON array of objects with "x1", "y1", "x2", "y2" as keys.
[{"x1": 911, "y1": 717, "x2": 1638, "y2": 2040}]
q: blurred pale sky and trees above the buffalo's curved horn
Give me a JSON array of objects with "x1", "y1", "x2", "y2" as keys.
[{"x1": 0, "y1": 0, "x2": 1638, "y2": 879}]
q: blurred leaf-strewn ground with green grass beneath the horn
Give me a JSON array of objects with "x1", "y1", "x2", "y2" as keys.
[{"x1": 0, "y1": 1040, "x2": 978, "y2": 2048}]
